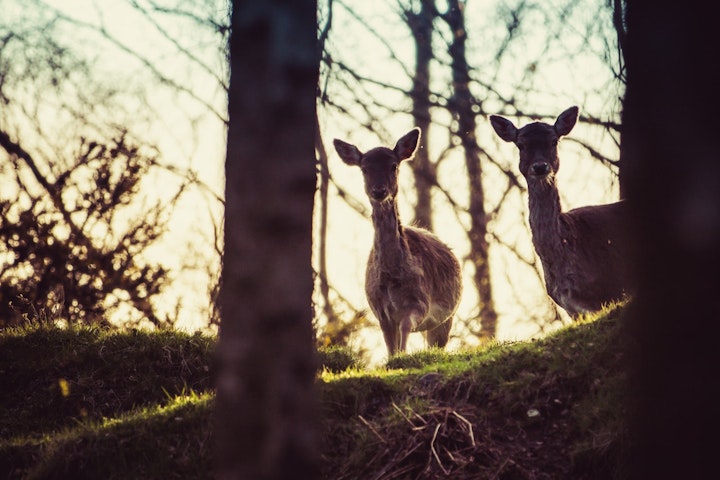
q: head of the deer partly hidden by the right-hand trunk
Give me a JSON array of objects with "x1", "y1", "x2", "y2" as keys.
[{"x1": 490, "y1": 107, "x2": 578, "y2": 183}]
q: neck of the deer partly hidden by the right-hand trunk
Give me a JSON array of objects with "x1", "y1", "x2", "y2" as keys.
[{"x1": 528, "y1": 176, "x2": 563, "y2": 262}]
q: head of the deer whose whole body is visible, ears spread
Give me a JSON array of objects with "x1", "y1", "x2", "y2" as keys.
[{"x1": 333, "y1": 128, "x2": 420, "y2": 203}]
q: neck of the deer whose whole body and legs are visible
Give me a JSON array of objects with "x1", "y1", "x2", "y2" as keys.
[{"x1": 372, "y1": 200, "x2": 408, "y2": 268}]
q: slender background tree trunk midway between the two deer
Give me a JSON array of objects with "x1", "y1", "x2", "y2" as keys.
[{"x1": 443, "y1": 0, "x2": 497, "y2": 340}]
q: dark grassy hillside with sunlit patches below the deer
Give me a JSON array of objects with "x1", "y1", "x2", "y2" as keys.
[{"x1": 0, "y1": 309, "x2": 626, "y2": 480}]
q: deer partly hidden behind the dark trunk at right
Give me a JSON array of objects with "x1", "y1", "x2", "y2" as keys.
[{"x1": 490, "y1": 106, "x2": 634, "y2": 319}]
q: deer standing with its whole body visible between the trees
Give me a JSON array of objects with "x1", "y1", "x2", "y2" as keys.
[{"x1": 333, "y1": 127, "x2": 462, "y2": 357}]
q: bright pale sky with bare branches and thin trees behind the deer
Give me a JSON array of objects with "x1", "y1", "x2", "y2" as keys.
[{"x1": 0, "y1": 0, "x2": 624, "y2": 364}]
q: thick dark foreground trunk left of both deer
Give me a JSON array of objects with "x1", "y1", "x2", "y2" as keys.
[{"x1": 215, "y1": 0, "x2": 318, "y2": 480}]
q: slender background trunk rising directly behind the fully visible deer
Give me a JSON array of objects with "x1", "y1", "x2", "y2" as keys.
[{"x1": 405, "y1": 0, "x2": 438, "y2": 230}]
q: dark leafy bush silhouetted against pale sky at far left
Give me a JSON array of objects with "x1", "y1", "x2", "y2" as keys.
[{"x1": 0, "y1": 136, "x2": 177, "y2": 327}]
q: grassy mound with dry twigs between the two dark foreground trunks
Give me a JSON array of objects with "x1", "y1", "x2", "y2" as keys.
[{"x1": 321, "y1": 310, "x2": 627, "y2": 480}]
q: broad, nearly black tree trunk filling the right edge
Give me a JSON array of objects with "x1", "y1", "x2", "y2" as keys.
[{"x1": 622, "y1": 1, "x2": 720, "y2": 479}]
